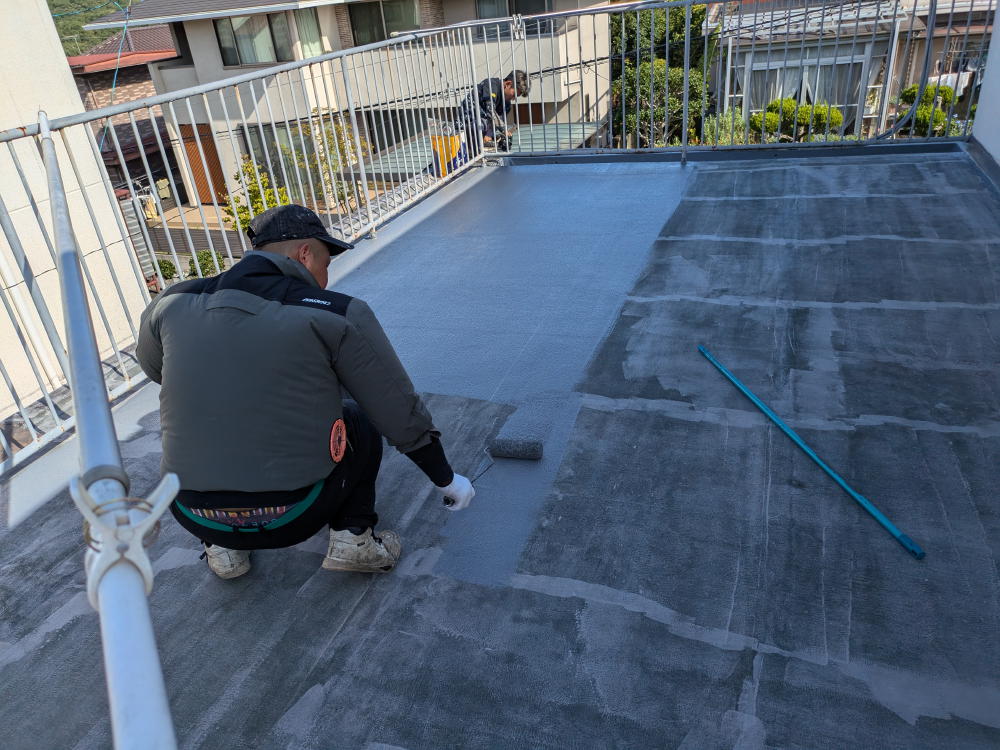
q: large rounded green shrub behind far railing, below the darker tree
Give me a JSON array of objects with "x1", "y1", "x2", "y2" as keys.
[{"x1": 612, "y1": 59, "x2": 705, "y2": 148}]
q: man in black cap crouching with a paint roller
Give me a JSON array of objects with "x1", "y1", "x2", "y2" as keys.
[{"x1": 137, "y1": 206, "x2": 475, "y2": 578}]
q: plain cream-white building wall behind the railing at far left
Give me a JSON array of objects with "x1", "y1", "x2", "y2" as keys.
[{"x1": 0, "y1": 0, "x2": 146, "y2": 418}]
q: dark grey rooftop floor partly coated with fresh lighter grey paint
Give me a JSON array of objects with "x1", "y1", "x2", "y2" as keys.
[{"x1": 0, "y1": 145, "x2": 1000, "y2": 750}]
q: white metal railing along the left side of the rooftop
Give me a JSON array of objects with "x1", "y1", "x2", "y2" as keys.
[{"x1": 0, "y1": 29, "x2": 482, "y2": 482}]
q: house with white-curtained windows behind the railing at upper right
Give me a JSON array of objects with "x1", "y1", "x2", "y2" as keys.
[{"x1": 712, "y1": 0, "x2": 994, "y2": 137}]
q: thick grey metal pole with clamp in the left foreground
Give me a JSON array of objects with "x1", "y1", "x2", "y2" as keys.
[{"x1": 38, "y1": 112, "x2": 178, "y2": 750}]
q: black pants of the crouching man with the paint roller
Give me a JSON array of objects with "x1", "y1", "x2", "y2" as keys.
[{"x1": 170, "y1": 401, "x2": 382, "y2": 549}]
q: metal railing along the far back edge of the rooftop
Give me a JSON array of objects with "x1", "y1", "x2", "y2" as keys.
[{"x1": 444, "y1": 0, "x2": 995, "y2": 156}]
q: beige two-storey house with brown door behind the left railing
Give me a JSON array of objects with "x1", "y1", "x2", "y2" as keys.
[{"x1": 87, "y1": 0, "x2": 607, "y2": 213}]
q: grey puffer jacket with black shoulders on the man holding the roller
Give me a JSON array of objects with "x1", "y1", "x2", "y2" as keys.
[{"x1": 136, "y1": 251, "x2": 451, "y2": 492}]
